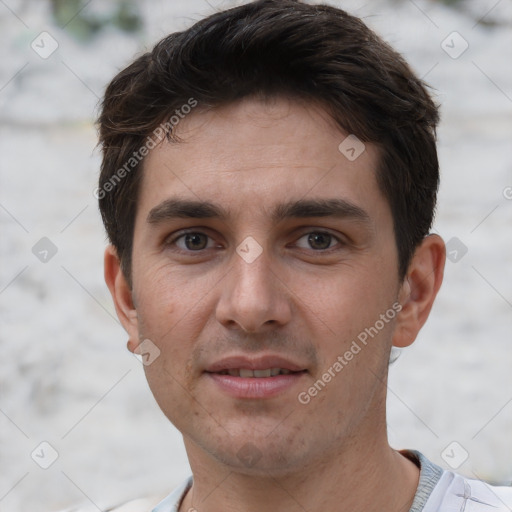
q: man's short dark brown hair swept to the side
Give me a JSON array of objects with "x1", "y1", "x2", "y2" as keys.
[{"x1": 98, "y1": 0, "x2": 439, "y2": 282}]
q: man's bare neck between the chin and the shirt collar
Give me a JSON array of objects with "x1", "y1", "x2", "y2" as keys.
[{"x1": 180, "y1": 435, "x2": 419, "y2": 512}]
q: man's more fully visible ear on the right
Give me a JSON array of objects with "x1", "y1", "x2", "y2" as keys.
[{"x1": 393, "y1": 235, "x2": 446, "y2": 347}]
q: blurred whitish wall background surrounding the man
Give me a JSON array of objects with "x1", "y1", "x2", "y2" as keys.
[{"x1": 0, "y1": 0, "x2": 512, "y2": 512}]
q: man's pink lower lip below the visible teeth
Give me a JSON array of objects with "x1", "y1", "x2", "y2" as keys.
[{"x1": 206, "y1": 372, "x2": 305, "y2": 398}]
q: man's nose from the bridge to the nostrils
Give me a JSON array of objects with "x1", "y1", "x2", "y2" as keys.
[{"x1": 216, "y1": 247, "x2": 291, "y2": 333}]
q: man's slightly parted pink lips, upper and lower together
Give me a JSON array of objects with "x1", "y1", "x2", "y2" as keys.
[{"x1": 205, "y1": 355, "x2": 307, "y2": 399}]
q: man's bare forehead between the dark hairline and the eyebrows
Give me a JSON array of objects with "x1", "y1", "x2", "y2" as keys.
[{"x1": 137, "y1": 99, "x2": 387, "y2": 224}]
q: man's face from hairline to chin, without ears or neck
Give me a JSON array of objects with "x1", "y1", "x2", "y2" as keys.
[{"x1": 111, "y1": 99, "x2": 416, "y2": 474}]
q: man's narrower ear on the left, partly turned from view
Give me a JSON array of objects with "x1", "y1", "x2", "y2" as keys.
[{"x1": 104, "y1": 245, "x2": 140, "y2": 352}]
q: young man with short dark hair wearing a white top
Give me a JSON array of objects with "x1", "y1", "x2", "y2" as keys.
[{"x1": 98, "y1": 0, "x2": 512, "y2": 512}]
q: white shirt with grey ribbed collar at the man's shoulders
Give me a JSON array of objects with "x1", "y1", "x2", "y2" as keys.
[{"x1": 152, "y1": 450, "x2": 512, "y2": 512}]
